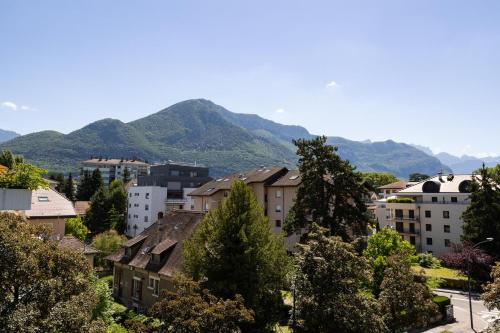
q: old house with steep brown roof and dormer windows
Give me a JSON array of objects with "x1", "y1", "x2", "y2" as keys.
[{"x1": 106, "y1": 210, "x2": 203, "y2": 312}]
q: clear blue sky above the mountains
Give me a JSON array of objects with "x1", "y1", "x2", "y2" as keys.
[{"x1": 0, "y1": 0, "x2": 500, "y2": 156}]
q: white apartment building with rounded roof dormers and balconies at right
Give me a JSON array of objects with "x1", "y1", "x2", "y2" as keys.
[{"x1": 376, "y1": 174, "x2": 472, "y2": 256}]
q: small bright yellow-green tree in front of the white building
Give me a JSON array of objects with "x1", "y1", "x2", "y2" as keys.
[{"x1": 363, "y1": 227, "x2": 415, "y2": 296}]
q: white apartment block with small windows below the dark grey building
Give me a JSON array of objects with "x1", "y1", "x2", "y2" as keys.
[{"x1": 127, "y1": 186, "x2": 167, "y2": 237}]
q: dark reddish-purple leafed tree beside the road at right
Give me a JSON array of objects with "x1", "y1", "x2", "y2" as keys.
[{"x1": 440, "y1": 242, "x2": 494, "y2": 281}]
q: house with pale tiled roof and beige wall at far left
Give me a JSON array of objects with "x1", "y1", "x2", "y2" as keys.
[{"x1": 24, "y1": 188, "x2": 77, "y2": 239}]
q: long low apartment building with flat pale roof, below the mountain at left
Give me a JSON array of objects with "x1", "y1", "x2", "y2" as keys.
[{"x1": 82, "y1": 157, "x2": 149, "y2": 186}]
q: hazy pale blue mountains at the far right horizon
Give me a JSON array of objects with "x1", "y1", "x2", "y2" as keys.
[{"x1": 412, "y1": 145, "x2": 500, "y2": 174}]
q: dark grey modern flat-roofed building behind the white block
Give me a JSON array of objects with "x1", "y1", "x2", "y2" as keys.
[{"x1": 137, "y1": 161, "x2": 212, "y2": 199}]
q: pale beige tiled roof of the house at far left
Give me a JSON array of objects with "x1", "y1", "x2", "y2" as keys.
[{"x1": 24, "y1": 188, "x2": 76, "y2": 218}]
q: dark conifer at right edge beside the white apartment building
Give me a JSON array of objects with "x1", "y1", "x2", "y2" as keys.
[{"x1": 462, "y1": 165, "x2": 500, "y2": 258}]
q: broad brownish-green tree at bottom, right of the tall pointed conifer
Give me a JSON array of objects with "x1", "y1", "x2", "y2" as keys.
[{"x1": 292, "y1": 224, "x2": 387, "y2": 333}]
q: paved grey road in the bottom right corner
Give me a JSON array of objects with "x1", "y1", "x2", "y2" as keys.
[{"x1": 425, "y1": 291, "x2": 500, "y2": 333}]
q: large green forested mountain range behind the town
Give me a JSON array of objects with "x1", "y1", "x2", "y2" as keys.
[{"x1": 0, "y1": 99, "x2": 449, "y2": 178}]
